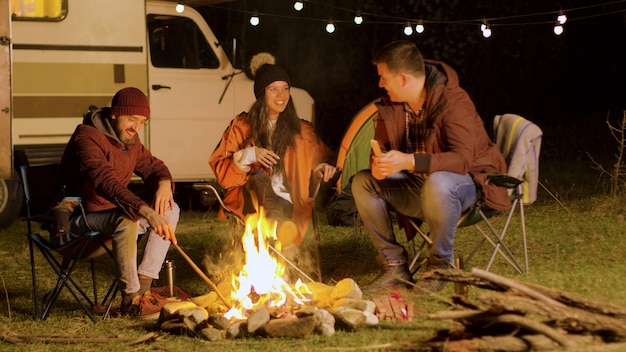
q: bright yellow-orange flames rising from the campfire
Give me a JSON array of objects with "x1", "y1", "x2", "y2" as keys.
[{"x1": 224, "y1": 208, "x2": 311, "y2": 319}]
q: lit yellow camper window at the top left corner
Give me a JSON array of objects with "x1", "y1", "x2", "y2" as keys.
[{"x1": 11, "y1": 0, "x2": 67, "y2": 21}]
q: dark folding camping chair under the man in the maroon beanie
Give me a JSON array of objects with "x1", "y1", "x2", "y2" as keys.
[{"x1": 20, "y1": 164, "x2": 117, "y2": 322}]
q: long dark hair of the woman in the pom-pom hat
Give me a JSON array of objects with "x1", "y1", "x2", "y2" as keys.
[{"x1": 248, "y1": 92, "x2": 300, "y2": 172}]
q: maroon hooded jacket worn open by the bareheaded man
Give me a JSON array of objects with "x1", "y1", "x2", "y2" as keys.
[{"x1": 374, "y1": 60, "x2": 510, "y2": 210}]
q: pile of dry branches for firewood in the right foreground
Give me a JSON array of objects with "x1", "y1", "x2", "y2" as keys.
[{"x1": 418, "y1": 269, "x2": 626, "y2": 351}]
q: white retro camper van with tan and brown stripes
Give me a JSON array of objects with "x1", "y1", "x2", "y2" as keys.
[{"x1": 0, "y1": 0, "x2": 314, "y2": 226}]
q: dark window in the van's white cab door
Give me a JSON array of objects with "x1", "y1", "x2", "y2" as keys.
[{"x1": 147, "y1": 15, "x2": 220, "y2": 69}]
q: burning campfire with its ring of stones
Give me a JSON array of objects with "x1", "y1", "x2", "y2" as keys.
[{"x1": 158, "y1": 209, "x2": 394, "y2": 341}]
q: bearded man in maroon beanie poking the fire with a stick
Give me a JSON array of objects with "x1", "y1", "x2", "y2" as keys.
[{"x1": 60, "y1": 88, "x2": 180, "y2": 315}]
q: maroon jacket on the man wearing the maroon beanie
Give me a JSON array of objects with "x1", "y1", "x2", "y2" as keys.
[{"x1": 61, "y1": 108, "x2": 173, "y2": 220}]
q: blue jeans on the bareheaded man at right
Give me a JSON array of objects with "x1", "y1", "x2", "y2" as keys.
[{"x1": 352, "y1": 170, "x2": 478, "y2": 265}]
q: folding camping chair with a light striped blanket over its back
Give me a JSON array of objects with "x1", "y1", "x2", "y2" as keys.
[{"x1": 409, "y1": 114, "x2": 542, "y2": 274}]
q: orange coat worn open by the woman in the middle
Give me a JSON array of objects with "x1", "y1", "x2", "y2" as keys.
[{"x1": 209, "y1": 112, "x2": 332, "y2": 245}]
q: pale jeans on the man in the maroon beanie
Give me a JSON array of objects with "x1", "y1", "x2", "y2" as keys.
[{"x1": 61, "y1": 204, "x2": 180, "y2": 294}]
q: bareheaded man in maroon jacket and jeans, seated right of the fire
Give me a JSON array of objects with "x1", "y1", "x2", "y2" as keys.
[{"x1": 352, "y1": 41, "x2": 510, "y2": 292}]
